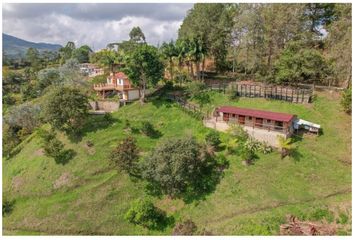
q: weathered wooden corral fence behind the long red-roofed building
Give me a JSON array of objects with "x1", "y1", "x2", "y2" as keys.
[{"x1": 209, "y1": 82, "x2": 313, "y2": 103}]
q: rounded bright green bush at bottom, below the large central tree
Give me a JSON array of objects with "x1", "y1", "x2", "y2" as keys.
[{"x1": 124, "y1": 199, "x2": 166, "y2": 229}]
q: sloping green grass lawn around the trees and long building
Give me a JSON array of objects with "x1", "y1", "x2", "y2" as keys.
[{"x1": 3, "y1": 92, "x2": 351, "y2": 235}]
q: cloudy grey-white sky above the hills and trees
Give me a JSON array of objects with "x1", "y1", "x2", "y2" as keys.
[{"x1": 3, "y1": 3, "x2": 193, "y2": 50}]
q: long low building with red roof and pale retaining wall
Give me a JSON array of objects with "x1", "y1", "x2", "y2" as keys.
[{"x1": 204, "y1": 106, "x2": 296, "y2": 147}]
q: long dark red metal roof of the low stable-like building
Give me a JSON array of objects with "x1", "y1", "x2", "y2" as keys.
[{"x1": 217, "y1": 106, "x2": 295, "y2": 122}]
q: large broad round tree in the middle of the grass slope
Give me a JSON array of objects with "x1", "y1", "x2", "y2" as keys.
[{"x1": 143, "y1": 137, "x2": 216, "y2": 197}]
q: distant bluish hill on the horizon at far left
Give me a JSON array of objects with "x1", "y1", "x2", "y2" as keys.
[{"x1": 2, "y1": 33, "x2": 62, "y2": 57}]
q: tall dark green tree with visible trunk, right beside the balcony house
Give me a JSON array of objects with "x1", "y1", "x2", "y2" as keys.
[{"x1": 125, "y1": 44, "x2": 164, "y2": 103}]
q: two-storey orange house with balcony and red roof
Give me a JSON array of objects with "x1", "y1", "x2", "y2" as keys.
[{"x1": 93, "y1": 72, "x2": 140, "y2": 101}]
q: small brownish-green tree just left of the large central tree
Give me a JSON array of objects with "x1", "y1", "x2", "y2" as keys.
[{"x1": 110, "y1": 136, "x2": 139, "y2": 175}]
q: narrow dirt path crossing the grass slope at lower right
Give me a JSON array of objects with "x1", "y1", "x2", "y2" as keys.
[{"x1": 206, "y1": 188, "x2": 352, "y2": 224}]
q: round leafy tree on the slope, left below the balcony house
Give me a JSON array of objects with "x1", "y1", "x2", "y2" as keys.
[{"x1": 42, "y1": 86, "x2": 89, "y2": 133}]
